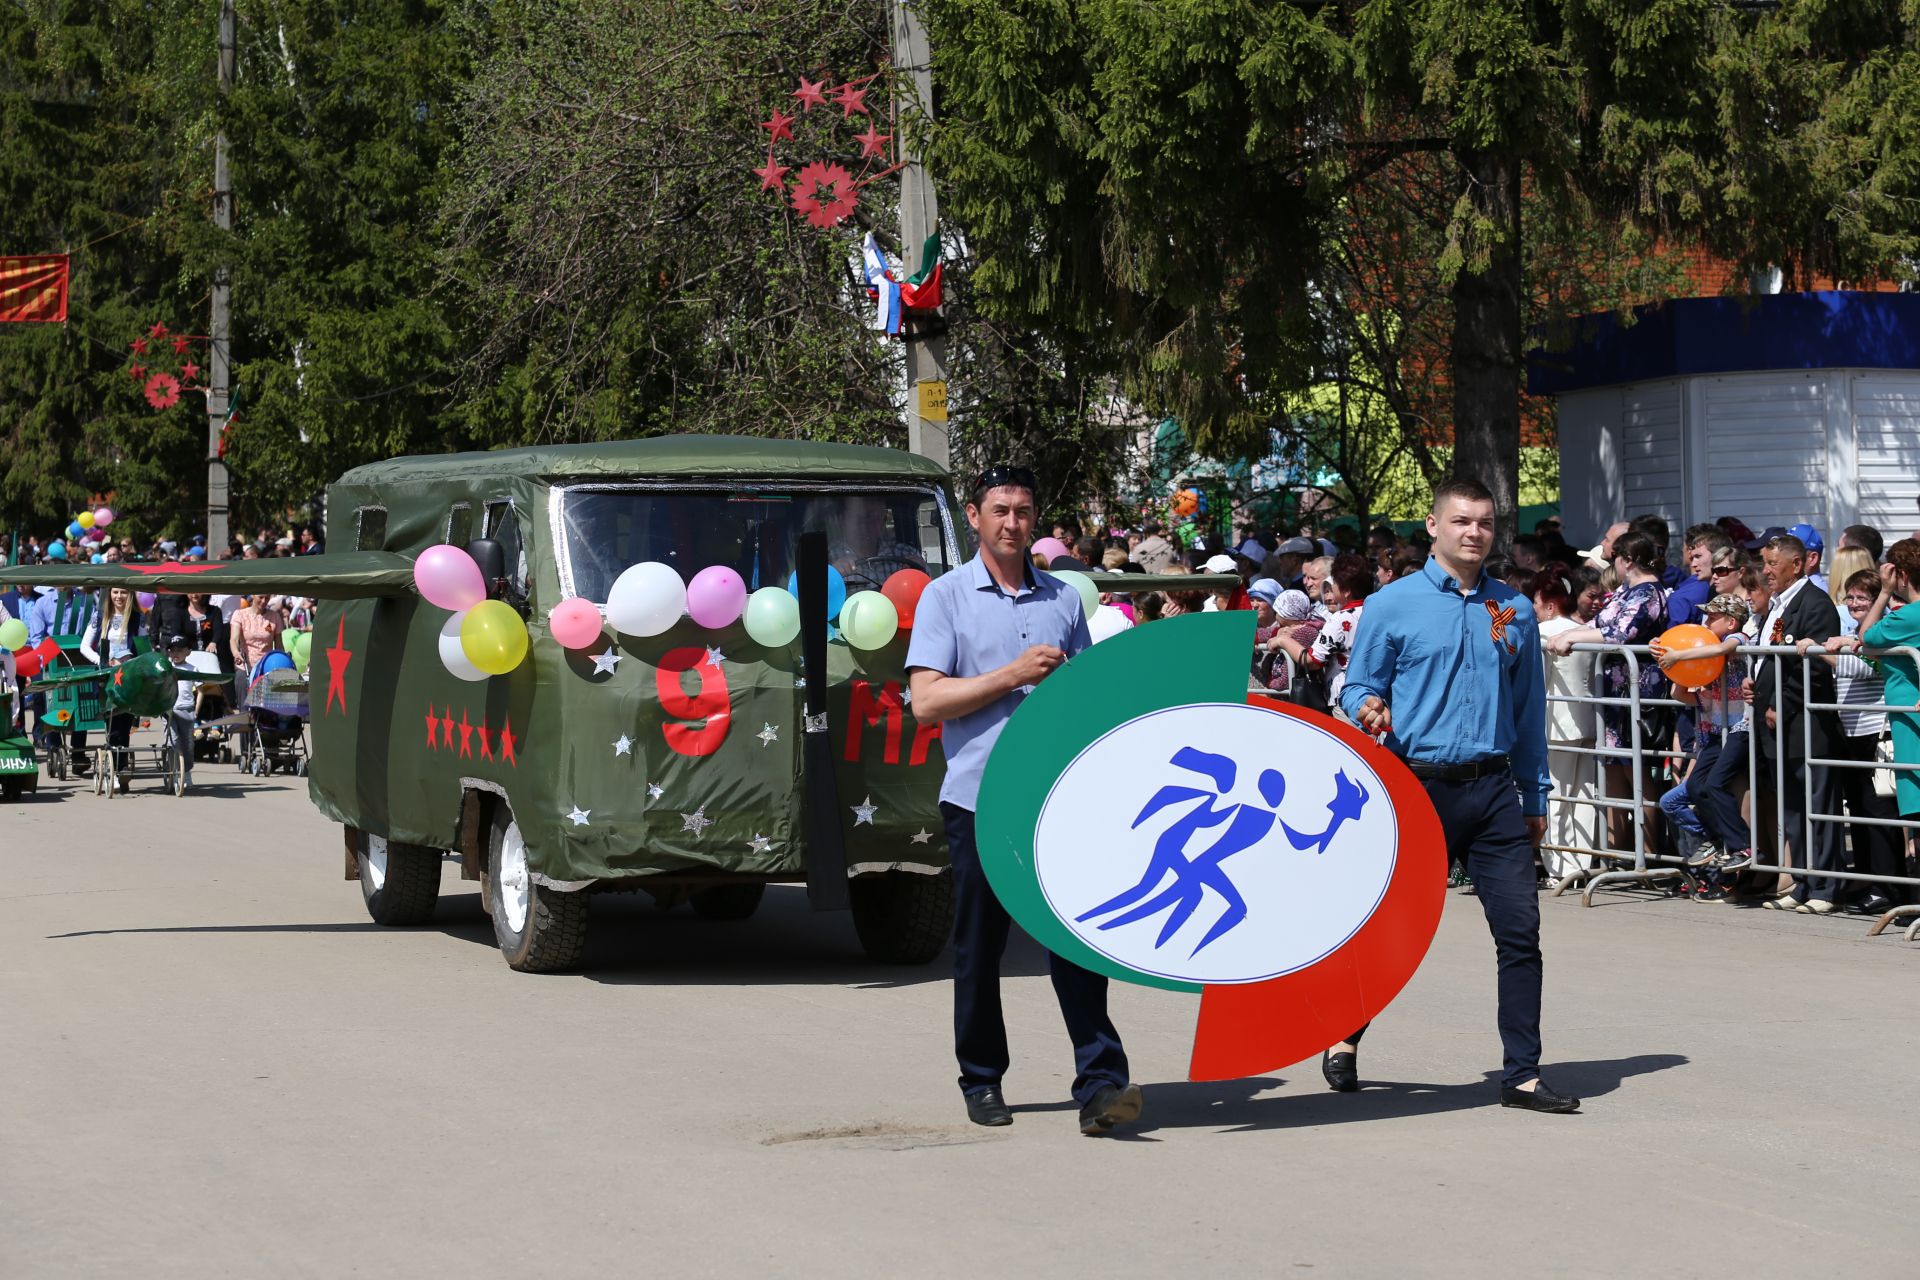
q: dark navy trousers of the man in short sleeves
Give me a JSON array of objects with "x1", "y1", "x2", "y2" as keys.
[{"x1": 941, "y1": 802, "x2": 1129, "y2": 1105}]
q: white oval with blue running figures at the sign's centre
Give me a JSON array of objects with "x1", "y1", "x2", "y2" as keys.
[{"x1": 1033, "y1": 702, "x2": 1400, "y2": 984}]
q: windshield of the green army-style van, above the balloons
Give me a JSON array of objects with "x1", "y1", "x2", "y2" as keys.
[{"x1": 561, "y1": 487, "x2": 952, "y2": 604}]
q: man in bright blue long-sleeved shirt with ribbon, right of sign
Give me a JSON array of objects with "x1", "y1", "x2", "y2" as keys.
[{"x1": 1321, "y1": 480, "x2": 1580, "y2": 1113}]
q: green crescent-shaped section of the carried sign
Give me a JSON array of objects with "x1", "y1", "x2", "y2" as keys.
[{"x1": 975, "y1": 610, "x2": 1254, "y2": 990}]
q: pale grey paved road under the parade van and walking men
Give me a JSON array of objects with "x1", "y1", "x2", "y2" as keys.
[{"x1": 11, "y1": 756, "x2": 1920, "y2": 1278}]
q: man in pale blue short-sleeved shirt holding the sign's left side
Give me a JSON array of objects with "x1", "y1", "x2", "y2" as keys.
[{"x1": 906, "y1": 466, "x2": 1140, "y2": 1136}]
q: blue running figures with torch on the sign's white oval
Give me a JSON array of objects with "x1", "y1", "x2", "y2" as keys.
[{"x1": 1075, "y1": 747, "x2": 1371, "y2": 958}]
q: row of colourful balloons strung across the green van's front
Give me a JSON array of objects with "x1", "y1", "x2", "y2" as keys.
[{"x1": 547, "y1": 560, "x2": 931, "y2": 649}]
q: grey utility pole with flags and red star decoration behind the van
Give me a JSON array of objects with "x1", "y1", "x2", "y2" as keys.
[{"x1": 893, "y1": 0, "x2": 947, "y2": 466}]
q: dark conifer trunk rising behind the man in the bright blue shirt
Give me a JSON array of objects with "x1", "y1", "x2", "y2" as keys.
[{"x1": 1453, "y1": 152, "x2": 1523, "y2": 547}]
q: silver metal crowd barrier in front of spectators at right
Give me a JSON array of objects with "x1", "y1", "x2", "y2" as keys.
[{"x1": 1540, "y1": 645, "x2": 1920, "y2": 942}]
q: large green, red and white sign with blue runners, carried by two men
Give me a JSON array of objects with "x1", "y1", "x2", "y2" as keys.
[{"x1": 977, "y1": 610, "x2": 1446, "y2": 1080}]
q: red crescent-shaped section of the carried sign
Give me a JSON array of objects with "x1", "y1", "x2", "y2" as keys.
[{"x1": 1187, "y1": 695, "x2": 1446, "y2": 1080}]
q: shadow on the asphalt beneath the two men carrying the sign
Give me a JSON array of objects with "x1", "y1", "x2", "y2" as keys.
[{"x1": 1113, "y1": 1054, "x2": 1690, "y2": 1136}]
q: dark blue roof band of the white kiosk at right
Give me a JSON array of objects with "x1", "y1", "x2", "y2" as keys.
[{"x1": 1526, "y1": 292, "x2": 1920, "y2": 395}]
